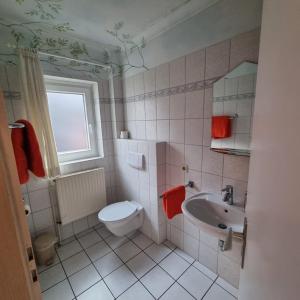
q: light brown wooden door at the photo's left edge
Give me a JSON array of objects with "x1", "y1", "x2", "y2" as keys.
[{"x1": 0, "y1": 91, "x2": 41, "y2": 300}]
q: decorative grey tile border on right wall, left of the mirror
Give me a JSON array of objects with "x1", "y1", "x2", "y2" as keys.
[{"x1": 124, "y1": 77, "x2": 221, "y2": 102}]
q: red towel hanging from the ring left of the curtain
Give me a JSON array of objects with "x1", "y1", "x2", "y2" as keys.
[{"x1": 11, "y1": 120, "x2": 45, "y2": 184}]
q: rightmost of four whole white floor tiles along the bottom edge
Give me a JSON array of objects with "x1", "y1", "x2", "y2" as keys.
[{"x1": 178, "y1": 266, "x2": 213, "y2": 299}]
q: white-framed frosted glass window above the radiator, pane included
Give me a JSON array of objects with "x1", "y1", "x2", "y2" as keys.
[{"x1": 45, "y1": 76, "x2": 99, "y2": 163}]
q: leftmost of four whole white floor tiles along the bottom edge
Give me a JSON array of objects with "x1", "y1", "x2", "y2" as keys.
[{"x1": 69, "y1": 265, "x2": 101, "y2": 296}]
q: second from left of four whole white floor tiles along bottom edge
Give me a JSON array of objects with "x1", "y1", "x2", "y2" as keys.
[{"x1": 104, "y1": 265, "x2": 137, "y2": 297}]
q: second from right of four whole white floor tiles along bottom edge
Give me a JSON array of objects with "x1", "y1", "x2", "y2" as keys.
[{"x1": 141, "y1": 266, "x2": 174, "y2": 298}]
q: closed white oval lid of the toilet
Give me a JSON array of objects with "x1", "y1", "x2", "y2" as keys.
[{"x1": 98, "y1": 201, "x2": 137, "y2": 222}]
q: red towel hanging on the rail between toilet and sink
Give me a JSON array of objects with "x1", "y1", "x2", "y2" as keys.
[{"x1": 163, "y1": 185, "x2": 185, "y2": 219}]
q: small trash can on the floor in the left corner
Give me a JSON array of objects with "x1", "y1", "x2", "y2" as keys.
[{"x1": 33, "y1": 232, "x2": 57, "y2": 266}]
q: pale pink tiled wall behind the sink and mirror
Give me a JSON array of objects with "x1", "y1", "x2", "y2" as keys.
[{"x1": 124, "y1": 30, "x2": 259, "y2": 286}]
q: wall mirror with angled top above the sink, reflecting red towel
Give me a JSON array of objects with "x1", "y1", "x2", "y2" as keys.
[{"x1": 211, "y1": 62, "x2": 257, "y2": 156}]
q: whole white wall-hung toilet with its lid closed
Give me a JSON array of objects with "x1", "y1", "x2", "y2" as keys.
[{"x1": 98, "y1": 201, "x2": 144, "y2": 236}]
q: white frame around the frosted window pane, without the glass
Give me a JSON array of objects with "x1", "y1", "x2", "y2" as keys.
[{"x1": 44, "y1": 75, "x2": 100, "y2": 164}]
